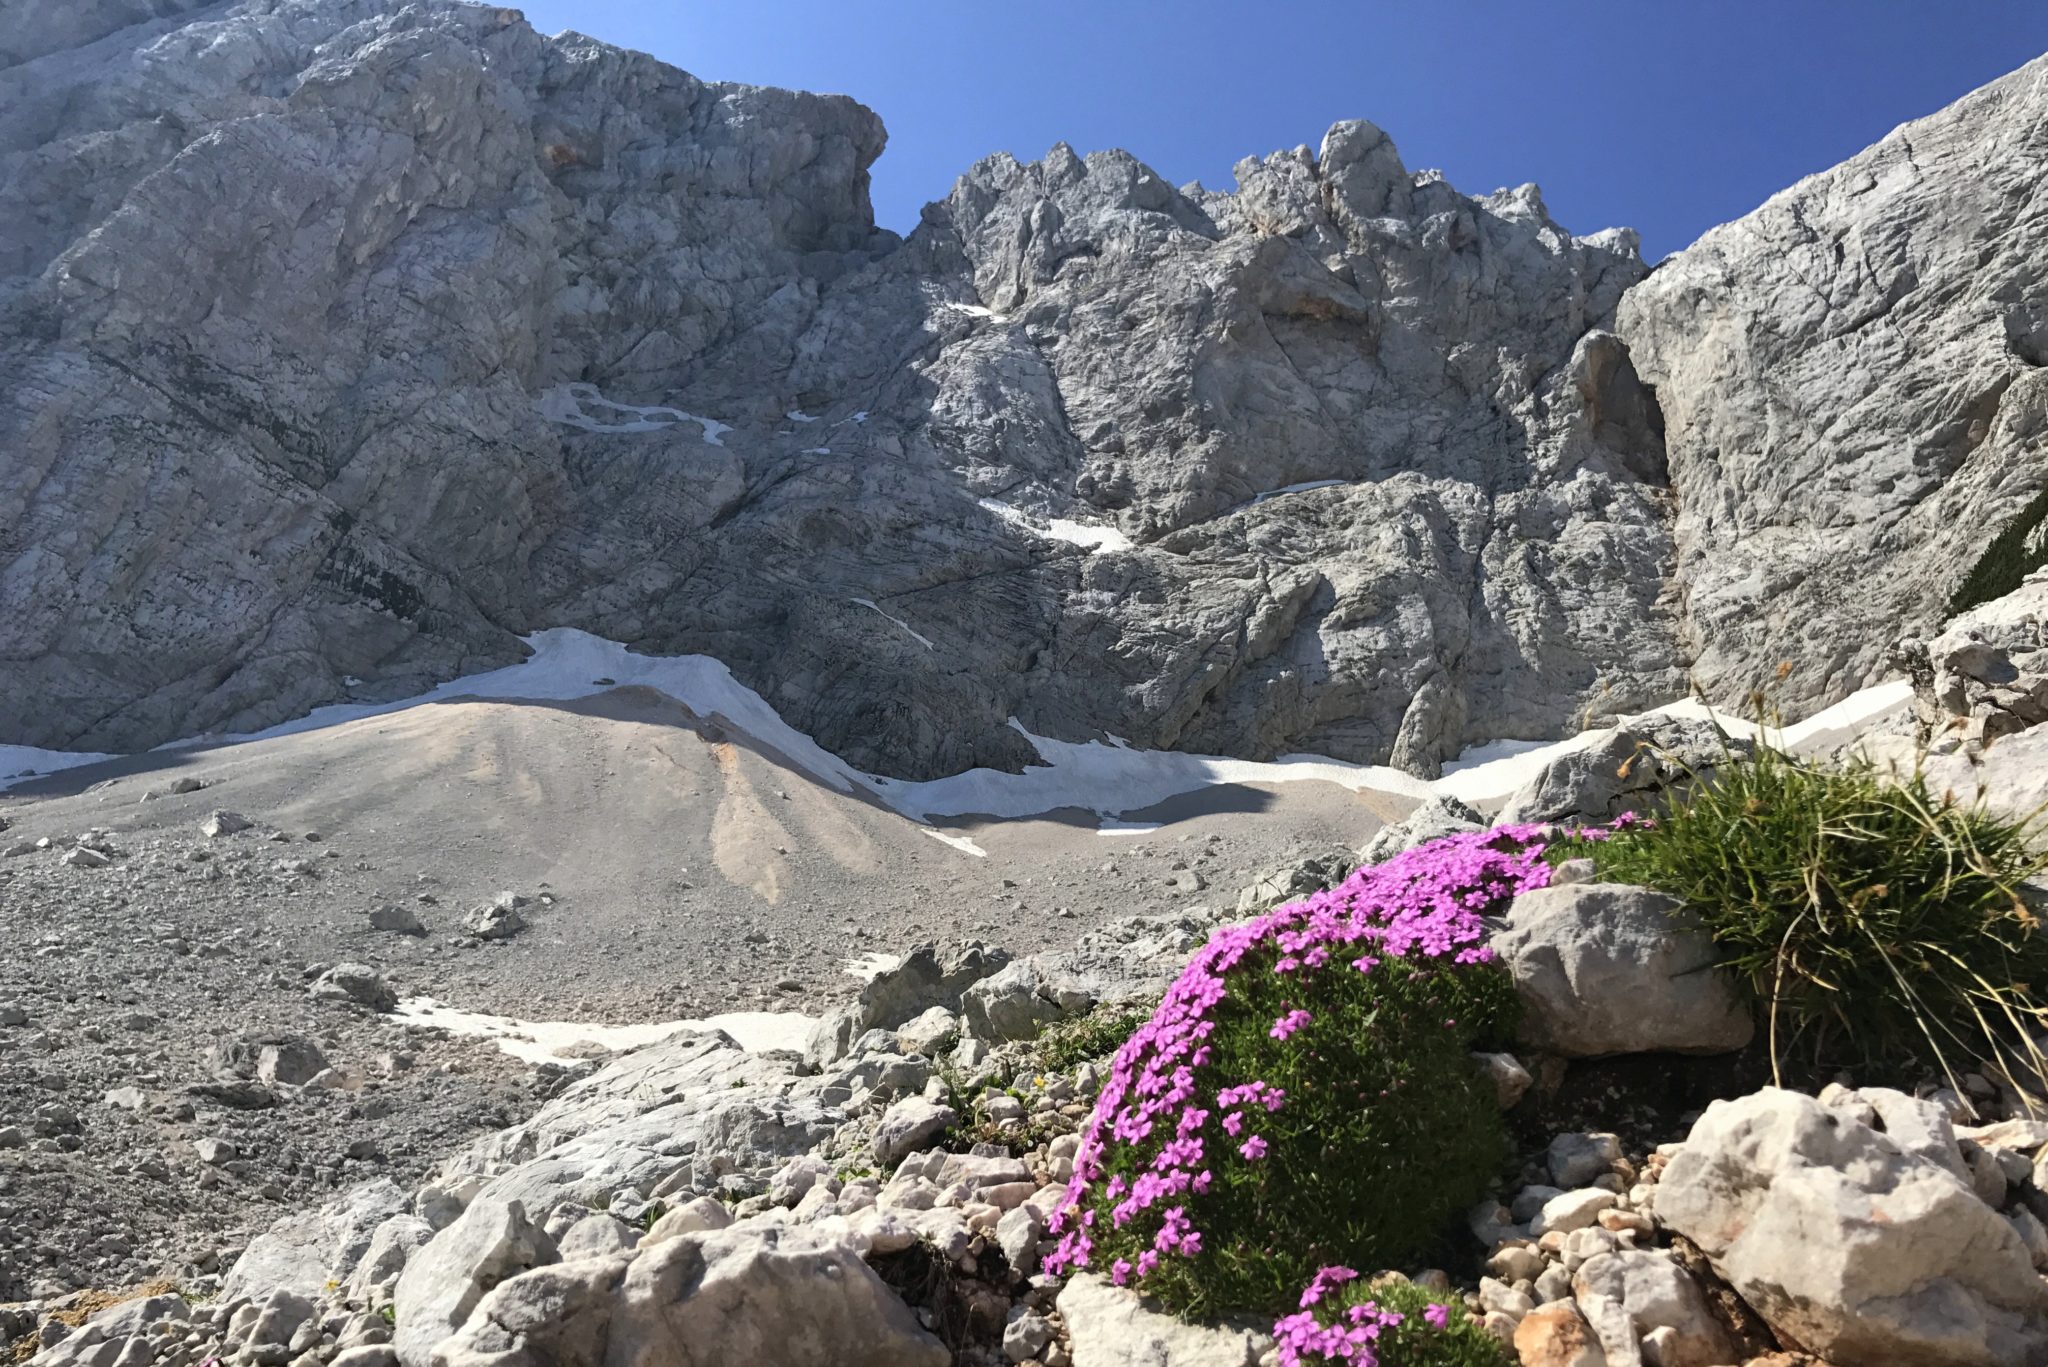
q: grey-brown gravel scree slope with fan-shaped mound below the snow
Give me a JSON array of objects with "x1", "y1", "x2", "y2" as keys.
[{"x1": 0, "y1": 691, "x2": 1372, "y2": 1299}]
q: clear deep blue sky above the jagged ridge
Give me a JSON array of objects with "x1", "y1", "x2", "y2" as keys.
[{"x1": 522, "y1": 0, "x2": 2048, "y2": 260}]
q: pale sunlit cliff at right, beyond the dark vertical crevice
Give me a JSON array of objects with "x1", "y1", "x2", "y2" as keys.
[{"x1": 1620, "y1": 57, "x2": 2048, "y2": 709}]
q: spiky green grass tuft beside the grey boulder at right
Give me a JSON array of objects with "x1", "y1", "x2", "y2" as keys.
[{"x1": 1550, "y1": 746, "x2": 2048, "y2": 1082}]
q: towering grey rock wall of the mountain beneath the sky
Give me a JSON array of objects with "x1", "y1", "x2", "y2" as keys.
[{"x1": 0, "y1": 0, "x2": 2048, "y2": 777}]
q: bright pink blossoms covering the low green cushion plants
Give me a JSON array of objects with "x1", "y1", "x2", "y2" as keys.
[{"x1": 1047, "y1": 826, "x2": 1550, "y2": 1367}]
